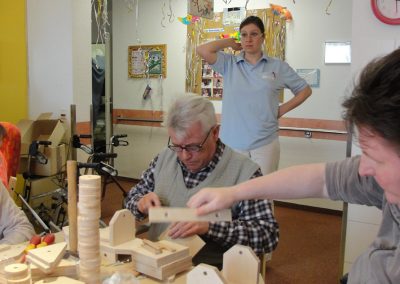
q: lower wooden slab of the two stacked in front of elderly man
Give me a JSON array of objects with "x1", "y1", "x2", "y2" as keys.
[{"x1": 135, "y1": 256, "x2": 192, "y2": 280}]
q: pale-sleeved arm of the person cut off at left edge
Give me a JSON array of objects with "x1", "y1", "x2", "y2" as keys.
[{"x1": 0, "y1": 182, "x2": 35, "y2": 244}]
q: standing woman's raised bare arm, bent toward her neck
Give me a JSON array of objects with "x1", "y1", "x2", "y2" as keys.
[{"x1": 196, "y1": 38, "x2": 242, "y2": 64}]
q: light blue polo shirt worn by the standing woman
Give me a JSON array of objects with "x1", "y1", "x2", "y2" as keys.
[{"x1": 212, "y1": 52, "x2": 308, "y2": 150}]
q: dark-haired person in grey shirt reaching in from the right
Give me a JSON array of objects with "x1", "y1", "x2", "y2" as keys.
[{"x1": 188, "y1": 49, "x2": 400, "y2": 283}]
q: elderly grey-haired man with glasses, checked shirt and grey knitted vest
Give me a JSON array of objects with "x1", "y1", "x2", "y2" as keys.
[{"x1": 125, "y1": 95, "x2": 279, "y2": 268}]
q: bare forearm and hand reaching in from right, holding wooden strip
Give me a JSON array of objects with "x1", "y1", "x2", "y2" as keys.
[{"x1": 188, "y1": 164, "x2": 328, "y2": 215}]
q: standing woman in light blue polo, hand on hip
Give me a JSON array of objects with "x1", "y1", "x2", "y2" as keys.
[{"x1": 197, "y1": 16, "x2": 311, "y2": 174}]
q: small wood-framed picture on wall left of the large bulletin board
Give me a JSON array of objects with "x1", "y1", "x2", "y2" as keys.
[{"x1": 128, "y1": 44, "x2": 167, "y2": 78}]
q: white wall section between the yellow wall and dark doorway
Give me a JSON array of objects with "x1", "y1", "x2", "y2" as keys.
[{"x1": 27, "y1": 0, "x2": 92, "y2": 121}]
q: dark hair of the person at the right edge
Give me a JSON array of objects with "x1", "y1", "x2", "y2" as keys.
[{"x1": 343, "y1": 49, "x2": 400, "y2": 149}]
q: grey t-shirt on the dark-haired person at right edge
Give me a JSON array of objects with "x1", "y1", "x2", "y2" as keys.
[{"x1": 325, "y1": 156, "x2": 400, "y2": 284}]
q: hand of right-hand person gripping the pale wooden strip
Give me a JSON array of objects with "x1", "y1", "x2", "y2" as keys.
[{"x1": 187, "y1": 187, "x2": 235, "y2": 215}]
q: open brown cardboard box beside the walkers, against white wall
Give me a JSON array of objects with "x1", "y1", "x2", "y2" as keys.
[{"x1": 17, "y1": 113, "x2": 68, "y2": 176}]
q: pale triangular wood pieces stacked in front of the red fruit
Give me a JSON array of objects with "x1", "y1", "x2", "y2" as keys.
[{"x1": 26, "y1": 242, "x2": 67, "y2": 273}]
